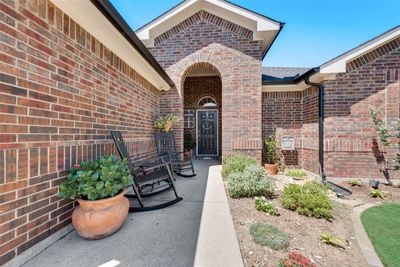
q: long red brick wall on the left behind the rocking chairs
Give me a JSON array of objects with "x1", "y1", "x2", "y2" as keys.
[{"x1": 0, "y1": 0, "x2": 160, "y2": 265}]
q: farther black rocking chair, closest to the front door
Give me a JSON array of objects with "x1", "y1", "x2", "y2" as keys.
[{"x1": 154, "y1": 132, "x2": 196, "y2": 177}]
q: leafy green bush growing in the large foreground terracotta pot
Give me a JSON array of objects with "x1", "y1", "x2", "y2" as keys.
[{"x1": 58, "y1": 156, "x2": 133, "y2": 200}]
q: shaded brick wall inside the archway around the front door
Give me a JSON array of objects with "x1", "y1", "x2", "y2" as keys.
[{"x1": 183, "y1": 76, "x2": 222, "y2": 155}]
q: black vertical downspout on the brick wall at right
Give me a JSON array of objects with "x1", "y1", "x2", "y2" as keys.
[{"x1": 304, "y1": 77, "x2": 326, "y2": 183}]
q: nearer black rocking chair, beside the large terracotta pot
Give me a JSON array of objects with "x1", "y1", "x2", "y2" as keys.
[{"x1": 111, "y1": 131, "x2": 183, "y2": 212}]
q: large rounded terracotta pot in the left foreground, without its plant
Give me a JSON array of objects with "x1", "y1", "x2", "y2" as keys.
[{"x1": 72, "y1": 190, "x2": 129, "y2": 239}]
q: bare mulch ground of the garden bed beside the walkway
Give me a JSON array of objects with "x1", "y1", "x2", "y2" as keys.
[{"x1": 225, "y1": 175, "x2": 400, "y2": 267}]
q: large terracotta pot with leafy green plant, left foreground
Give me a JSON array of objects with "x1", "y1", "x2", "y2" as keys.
[{"x1": 58, "y1": 156, "x2": 133, "y2": 239}]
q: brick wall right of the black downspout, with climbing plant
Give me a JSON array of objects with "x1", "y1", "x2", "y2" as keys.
[{"x1": 325, "y1": 38, "x2": 400, "y2": 178}]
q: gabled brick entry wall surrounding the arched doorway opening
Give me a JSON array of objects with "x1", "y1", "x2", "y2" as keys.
[{"x1": 150, "y1": 11, "x2": 262, "y2": 159}]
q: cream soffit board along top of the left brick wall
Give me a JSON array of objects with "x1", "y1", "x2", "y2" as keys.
[{"x1": 51, "y1": 0, "x2": 170, "y2": 91}]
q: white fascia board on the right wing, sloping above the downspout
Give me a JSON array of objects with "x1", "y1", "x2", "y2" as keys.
[{"x1": 320, "y1": 26, "x2": 400, "y2": 73}]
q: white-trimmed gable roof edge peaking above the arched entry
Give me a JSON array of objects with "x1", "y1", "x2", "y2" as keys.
[{"x1": 136, "y1": 0, "x2": 284, "y2": 57}]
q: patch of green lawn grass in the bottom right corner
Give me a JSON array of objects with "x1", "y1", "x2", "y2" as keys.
[{"x1": 361, "y1": 204, "x2": 400, "y2": 267}]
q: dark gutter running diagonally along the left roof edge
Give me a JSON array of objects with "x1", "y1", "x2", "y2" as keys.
[{"x1": 90, "y1": 0, "x2": 175, "y2": 87}]
